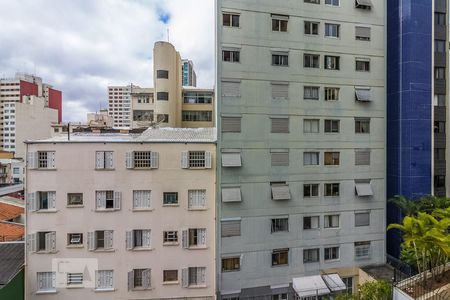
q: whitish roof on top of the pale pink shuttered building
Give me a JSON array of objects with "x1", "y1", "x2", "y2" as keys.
[{"x1": 26, "y1": 127, "x2": 217, "y2": 144}]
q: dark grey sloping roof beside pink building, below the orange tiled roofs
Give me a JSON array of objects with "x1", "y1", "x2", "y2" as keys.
[{"x1": 0, "y1": 242, "x2": 25, "y2": 287}]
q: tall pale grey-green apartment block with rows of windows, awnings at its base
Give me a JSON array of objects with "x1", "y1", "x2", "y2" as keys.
[{"x1": 216, "y1": 0, "x2": 386, "y2": 299}]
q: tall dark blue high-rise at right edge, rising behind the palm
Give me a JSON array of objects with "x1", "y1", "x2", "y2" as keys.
[{"x1": 387, "y1": 0, "x2": 450, "y2": 257}]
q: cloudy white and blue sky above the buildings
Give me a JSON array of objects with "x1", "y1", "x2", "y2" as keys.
[{"x1": 0, "y1": 0, "x2": 214, "y2": 121}]
